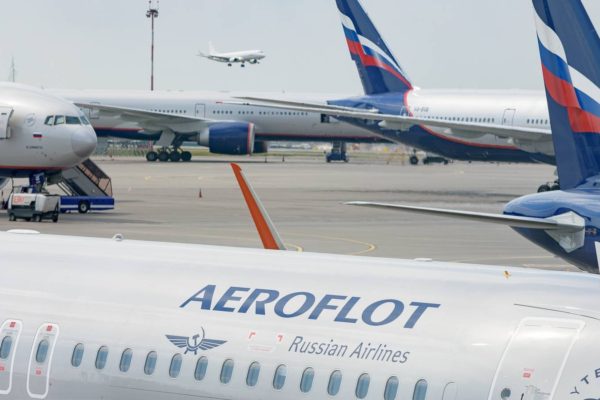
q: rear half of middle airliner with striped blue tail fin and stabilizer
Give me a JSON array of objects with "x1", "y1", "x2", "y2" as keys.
[{"x1": 231, "y1": 0, "x2": 576, "y2": 173}]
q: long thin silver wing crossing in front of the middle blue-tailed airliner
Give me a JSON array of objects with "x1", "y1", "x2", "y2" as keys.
[{"x1": 232, "y1": 97, "x2": 552, "y2": 141}]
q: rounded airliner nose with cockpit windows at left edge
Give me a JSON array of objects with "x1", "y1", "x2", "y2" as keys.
[{"x1": 0, "y1": 82, "x2": 96, "y2": 186}]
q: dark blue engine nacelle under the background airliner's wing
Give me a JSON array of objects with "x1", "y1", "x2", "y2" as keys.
[{"x1": 198, "y1": 122, "x2": 254, "y2": 155}]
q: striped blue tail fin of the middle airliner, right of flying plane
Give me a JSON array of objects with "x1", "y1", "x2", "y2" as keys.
[{"x1": 336, "y1": 0, "x2": 412, "y2": 94}]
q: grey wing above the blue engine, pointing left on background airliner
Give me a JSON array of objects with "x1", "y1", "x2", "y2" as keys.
[{"x1": 75, "y1": 102, "x2": 215, "y2": 133}]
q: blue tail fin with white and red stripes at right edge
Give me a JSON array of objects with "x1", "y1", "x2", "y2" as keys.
[{"x1": 533, "y1": 0, "x2": 600, "y2": 189}]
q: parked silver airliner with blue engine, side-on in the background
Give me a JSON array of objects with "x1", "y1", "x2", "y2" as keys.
[{"x1": 52, "y1": 90, "x2": 380, "y2": 161}]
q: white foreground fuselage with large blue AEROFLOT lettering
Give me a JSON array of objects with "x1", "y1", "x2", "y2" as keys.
[{"x1": 0, "y1": 233, "x2": 600, "y2": 400}]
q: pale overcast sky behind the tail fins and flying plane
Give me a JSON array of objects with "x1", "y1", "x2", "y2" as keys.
[{"x1": 0, "y1": 0, "x2": 600, "y2": 94}]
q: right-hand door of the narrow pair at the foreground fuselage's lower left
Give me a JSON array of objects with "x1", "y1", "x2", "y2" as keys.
[{"x1": 27, "y1": 324, "x2": 59, "y2": 399}]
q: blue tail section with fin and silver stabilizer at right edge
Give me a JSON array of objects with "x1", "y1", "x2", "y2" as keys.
[{"x1": 350, "y1": 0, "x2": 600, "y2": 274}]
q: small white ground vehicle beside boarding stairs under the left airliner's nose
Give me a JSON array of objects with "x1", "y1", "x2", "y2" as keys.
[{"x1": 8, "y1": 186, "x2": 60, "y2": 222}]
